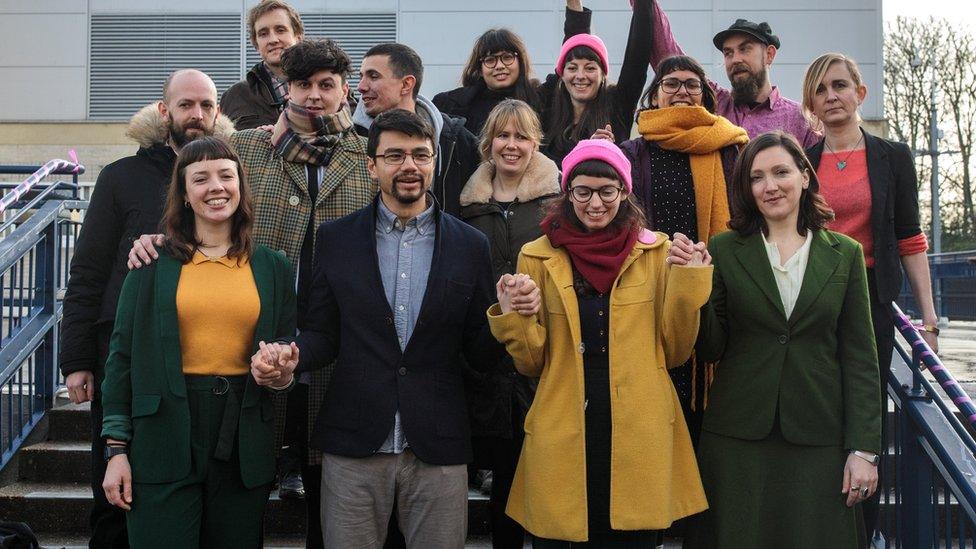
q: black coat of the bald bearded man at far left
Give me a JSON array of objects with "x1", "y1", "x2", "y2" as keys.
[{"x1": 59, "y1": 143, "x2": 176, "y2": 376}]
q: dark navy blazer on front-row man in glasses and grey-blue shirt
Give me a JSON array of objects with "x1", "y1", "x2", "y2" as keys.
[{"x1": 297, "y1": 198, "x2": 502, "y2": 465}]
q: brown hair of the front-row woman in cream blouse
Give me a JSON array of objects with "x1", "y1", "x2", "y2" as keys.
[{"x1": 729, "y1": 130, "x2": 834, "y2": 236}]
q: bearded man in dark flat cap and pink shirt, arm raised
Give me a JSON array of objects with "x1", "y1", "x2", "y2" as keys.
[{"x1": 651, "y1": 2, "x2": 820, "y2": 147}]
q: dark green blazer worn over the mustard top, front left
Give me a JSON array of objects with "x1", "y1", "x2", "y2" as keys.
[{"x1": 102, "y1": 246, "x2": 295, "y2": 488}]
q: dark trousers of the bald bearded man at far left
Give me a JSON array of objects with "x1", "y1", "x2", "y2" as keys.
[{"x1": 88, "y1": 330, "x2": 129, "y2": 549}]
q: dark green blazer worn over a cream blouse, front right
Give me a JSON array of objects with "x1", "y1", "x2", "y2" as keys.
[{"x1": 696, "y1": 230, "x2": 881, "y2": 453}]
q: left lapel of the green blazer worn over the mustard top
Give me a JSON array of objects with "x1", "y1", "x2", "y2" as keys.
[{"x1": 155, "y1": 254, "x2": 186, "y2": 397}]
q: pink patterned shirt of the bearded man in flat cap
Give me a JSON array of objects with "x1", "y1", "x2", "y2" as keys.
[{"x1": 651, "y1": 2, "x2": 820, "y2": 148}]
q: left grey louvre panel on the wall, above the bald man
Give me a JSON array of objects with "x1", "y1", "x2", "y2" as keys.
[{"x1": 88, "y1": 13, "x2": 241, "y2": 120}]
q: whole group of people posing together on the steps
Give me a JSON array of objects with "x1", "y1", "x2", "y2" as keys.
[{"x1": 60, "y1": 0, "x2": 938, "y2": 549}]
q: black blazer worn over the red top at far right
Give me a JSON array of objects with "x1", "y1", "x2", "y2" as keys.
[{"x1": 807, "y1": 128, "x2": 922, "y2": 303}]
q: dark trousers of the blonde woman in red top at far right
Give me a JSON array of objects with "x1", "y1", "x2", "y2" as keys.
[{"x1": 861, "y1": 269, "x2": 895, "y2": 541}]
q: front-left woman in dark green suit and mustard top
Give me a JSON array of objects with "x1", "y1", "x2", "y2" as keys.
[{"x1": 102, "y1": 137, "x2": 297, "y2": 549}]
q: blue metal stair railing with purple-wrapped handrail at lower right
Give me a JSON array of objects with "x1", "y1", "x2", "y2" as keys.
[{"x1": 874, "y1": 305, "x2": 976, "y2": 549}]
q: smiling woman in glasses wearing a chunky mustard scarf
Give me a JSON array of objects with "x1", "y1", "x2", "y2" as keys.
[{"x1": 620, "y1": 55, "x2": 749, "y2": 444}]
